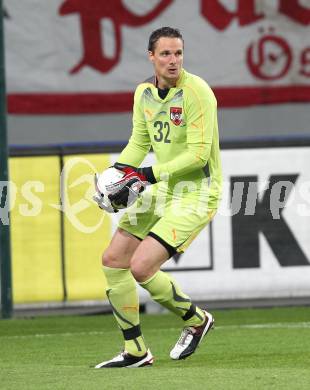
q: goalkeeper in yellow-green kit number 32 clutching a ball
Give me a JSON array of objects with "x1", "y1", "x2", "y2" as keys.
[{"x1": 96, "y1": 27, "x2": 222, "y2": 368}]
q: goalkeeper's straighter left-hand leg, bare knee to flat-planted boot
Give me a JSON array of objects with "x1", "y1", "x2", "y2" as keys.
[{"x1": 96, "y1": 229, "x2": 152, "y2": 368}]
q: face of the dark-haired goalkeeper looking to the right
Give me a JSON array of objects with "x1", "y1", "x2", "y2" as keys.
[{"x1": 149, "y1": 37, "x2": 183, "y2": 88}]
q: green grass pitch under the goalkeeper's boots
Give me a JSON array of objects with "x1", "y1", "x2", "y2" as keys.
[{"x1": 0, "y1": 307, "x2": 310, "y2": 390}]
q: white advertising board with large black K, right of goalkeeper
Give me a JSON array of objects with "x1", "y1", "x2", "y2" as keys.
[{"x1": 160, "y1": 147, "x2": 310, "y2": 300}]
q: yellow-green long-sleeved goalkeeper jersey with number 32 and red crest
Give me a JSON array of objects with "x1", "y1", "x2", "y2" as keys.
[{"x1": 117, "y1": 69, "x2": 222, "y2": 208}]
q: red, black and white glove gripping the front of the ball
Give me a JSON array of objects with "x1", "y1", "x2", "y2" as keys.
[{"x1": 109, "y1": 163, "x2": 156, "y2": 208}]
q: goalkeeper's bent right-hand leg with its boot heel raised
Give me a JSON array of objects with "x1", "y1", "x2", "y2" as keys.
[{"x1": 130, "y1": 236, "x2": 214, "y2": 359}]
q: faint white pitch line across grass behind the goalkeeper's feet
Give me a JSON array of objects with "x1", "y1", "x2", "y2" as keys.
[{"x1": 0, "y1": 322, "x2": 310, "y2": 340}]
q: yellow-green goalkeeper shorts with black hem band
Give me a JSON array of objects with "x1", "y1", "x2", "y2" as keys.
[{"x1": 119, "y1": 186, "x2": 216, "y2": 255}]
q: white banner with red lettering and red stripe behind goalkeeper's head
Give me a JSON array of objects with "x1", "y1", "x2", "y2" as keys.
[{"x1": 4, "y1": 0, "x2": 310, "y2": 114}]
